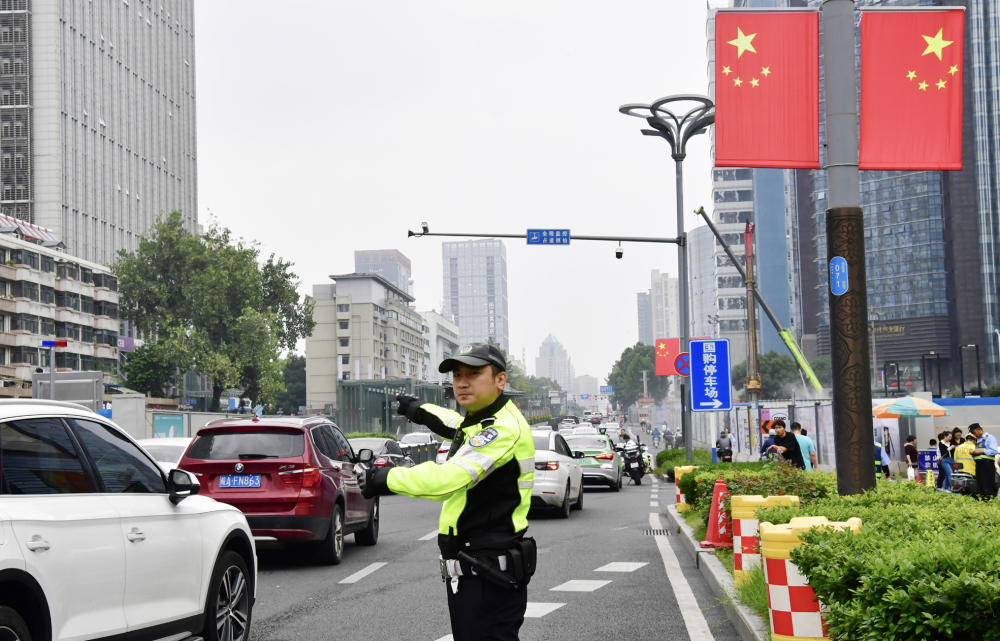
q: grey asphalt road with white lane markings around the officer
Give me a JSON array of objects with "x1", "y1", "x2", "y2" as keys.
[{"x1": 251, "y1": 440, "x2": 739, "y2": 641}]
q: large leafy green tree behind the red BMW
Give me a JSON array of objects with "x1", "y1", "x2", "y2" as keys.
[{"x1": 114, "y1": 212, "x2": 314, "y2": 411}]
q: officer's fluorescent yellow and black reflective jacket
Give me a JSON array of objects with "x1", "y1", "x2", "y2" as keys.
[{"x1": 386, "y1": 395, "x2": 535, "y2": 558}]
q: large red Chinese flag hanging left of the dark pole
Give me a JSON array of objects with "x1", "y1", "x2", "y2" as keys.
[{"x1": 715, "y1": 11, "x2": 819, "y2": 169}]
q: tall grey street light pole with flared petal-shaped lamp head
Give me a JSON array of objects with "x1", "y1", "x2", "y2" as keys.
[{"x1": 618, "y1": 95, "x2": 715, "y2": 461}]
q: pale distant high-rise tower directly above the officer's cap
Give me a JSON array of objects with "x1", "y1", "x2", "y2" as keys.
[{"x1": 441, "y1": 240, "x2": 510, "y2": 350}]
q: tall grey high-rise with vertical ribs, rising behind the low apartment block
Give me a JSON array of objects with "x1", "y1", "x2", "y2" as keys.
[{"x1": 0, "y1": 0, "x2": 198, "y2": 265}]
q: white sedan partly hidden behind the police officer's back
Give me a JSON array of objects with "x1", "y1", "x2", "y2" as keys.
[{"x1": 531, "y1": 432, "x2": 583, "y2": 519}]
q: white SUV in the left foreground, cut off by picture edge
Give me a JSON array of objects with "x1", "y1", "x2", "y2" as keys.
[{"x1": 0, "y1": 400, "x2": 257, "y2": 641}]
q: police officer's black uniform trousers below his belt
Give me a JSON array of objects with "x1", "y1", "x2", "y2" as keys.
[{"x1": 445, "y1": 576, "x2": 528, "y2": 641}]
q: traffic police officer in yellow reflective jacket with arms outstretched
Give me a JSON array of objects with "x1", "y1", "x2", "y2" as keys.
[{"x1": 358, "y1": 343, "x2": 536, "y2": 641}]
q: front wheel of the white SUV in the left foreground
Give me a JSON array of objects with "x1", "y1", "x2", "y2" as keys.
[{"x1": 202, "y1": 552, "x2": 253, "y2": 641}]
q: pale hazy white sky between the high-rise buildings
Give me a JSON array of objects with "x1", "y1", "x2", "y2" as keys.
[{"x1": 195, "y1": 0, "x2": 711, "y2": 380}]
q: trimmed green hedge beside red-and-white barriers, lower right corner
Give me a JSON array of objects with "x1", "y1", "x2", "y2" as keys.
[{"x1": 757, "y1": 481, "x2": 1000, "y2": 641}]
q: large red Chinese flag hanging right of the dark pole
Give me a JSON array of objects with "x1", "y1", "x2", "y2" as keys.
[{"x1": 859, "y1": 10, "x2": 965, "y2": 170}]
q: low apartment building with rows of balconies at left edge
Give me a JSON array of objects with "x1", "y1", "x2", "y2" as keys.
[{"x1": 0, "y1": 215, "x2": 119, "y2": 381}]
